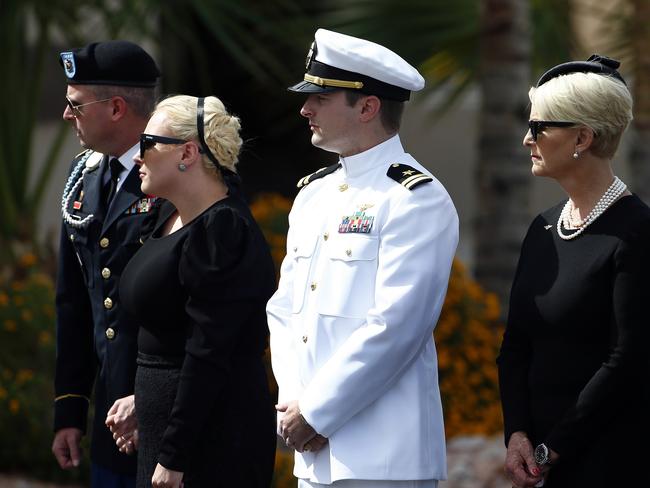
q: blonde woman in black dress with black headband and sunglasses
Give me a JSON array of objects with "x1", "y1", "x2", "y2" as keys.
[{"x1": 120, "y1": 96, "x2": 275, "y2": 488}]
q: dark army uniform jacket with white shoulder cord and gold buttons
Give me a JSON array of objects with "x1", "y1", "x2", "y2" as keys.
[{"x1": 54, "y1": 150, "x2": 153, "y2": 474}]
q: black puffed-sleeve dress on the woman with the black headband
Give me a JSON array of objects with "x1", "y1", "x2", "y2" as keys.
[{"x1": 120, "y1": 195, "x2": 276, "y2": 488}]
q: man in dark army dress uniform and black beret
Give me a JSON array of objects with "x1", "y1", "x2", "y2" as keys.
[{"x1": 52, "y1": 41, "x2": 160, "y2": 488}]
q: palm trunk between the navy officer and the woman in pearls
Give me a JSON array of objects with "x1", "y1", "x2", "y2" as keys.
[{"x1": 474, "y1": 0, "x2": 532, "y2": 316}]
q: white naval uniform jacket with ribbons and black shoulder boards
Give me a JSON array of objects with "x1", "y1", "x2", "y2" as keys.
[{"x1": 267, "y1": 136, "x2": 458, "y2": 483}]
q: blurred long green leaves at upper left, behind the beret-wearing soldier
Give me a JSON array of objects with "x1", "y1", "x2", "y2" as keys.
[{"x1": 0, "y1": 0, "x2": 95, "y2": 264}]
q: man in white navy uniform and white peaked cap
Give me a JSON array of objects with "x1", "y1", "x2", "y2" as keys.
[{"x1": 267, "y1": 29, "x2": 458, "y2": 488}]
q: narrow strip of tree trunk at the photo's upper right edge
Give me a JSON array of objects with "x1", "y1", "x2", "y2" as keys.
[{"x1": 629, "y1": 0, "x2": 650, "y2": 204}]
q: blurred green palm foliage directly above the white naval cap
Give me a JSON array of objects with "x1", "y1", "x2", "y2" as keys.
[{"x1": 323, "y1": 0, "x2": 481, "y2": 112}]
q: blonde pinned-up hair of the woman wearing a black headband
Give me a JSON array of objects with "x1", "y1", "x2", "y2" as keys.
[{"x1": 154, "y1": 95, "x2": 242, "y2": 173}]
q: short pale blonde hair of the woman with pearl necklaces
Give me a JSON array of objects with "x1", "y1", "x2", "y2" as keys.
[{"x1": 528, "y1": 73, "x2": 632, "y2": 159}]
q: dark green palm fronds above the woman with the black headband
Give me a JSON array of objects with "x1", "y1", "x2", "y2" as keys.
[{"x1": 130, "y1": 0, "x2": 312, "y2": 91}]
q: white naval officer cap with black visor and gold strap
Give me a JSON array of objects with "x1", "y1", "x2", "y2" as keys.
[{"x1": 288, "y1": 29, "x2": 424, "y2": 102}]
